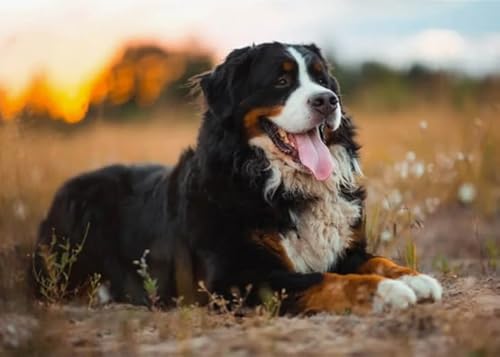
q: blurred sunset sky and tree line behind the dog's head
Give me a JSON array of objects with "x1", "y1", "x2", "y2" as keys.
[{"x1": 0, "y1": 0, "x2": 500, "y2": 124}]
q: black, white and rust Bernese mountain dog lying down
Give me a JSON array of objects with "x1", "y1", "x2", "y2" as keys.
[{"x1": 33, "y1": 42, "x2": 442, "y2": 314}]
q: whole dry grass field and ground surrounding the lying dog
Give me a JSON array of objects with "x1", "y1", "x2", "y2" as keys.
[{"x1": 0, "y1": 106, "x2": 500, "y2": 356}]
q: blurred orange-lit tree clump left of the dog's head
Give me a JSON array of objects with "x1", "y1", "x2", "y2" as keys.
[{"x1": 91, "y1": 44, "x2": 212, "y2": 119}]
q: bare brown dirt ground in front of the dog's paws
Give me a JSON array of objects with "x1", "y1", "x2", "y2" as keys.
[{"x1": 0, "y1": 275, "x2": 500, "y2": 356}]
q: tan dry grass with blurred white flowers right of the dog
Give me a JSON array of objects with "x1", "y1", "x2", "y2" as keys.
[{"x1": 358, "y1": 104, "x2": 500, "y2": 264}]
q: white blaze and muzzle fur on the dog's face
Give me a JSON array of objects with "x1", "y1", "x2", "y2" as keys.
[{"x1": 272, "y1": 47, "x2": 341, "y2": 133}]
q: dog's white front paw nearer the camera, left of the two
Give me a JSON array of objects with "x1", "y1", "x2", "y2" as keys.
[{"x1": 373, "y1": 279, "x2": 417, "y2": 312}]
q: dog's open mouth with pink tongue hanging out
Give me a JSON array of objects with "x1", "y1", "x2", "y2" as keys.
[{"x1": 260, "y1": 118, "x2": 333, "y2": 181}]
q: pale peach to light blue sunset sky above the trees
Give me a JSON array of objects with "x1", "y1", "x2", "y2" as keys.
[{"x1": 0, "y1": 0, "x2": 500, "y2": 92}]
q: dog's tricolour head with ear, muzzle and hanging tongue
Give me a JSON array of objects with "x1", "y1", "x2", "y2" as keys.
[{"x1": 200, "y1": 43, "x2": 342, "y2": 180}]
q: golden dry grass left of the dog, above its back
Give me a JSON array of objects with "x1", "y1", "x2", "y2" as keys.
[{"x1": 0, "y1": 108, "x2": 197, "y2": 245}]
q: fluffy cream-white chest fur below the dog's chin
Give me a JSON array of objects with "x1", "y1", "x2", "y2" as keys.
[{"x1": 250, "y1": 138, "x2": 361, "y2": 273}]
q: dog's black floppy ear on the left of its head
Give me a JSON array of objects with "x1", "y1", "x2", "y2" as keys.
[{"x1": 194, "y1": 47, "x2": 251, "y2": 118}]
